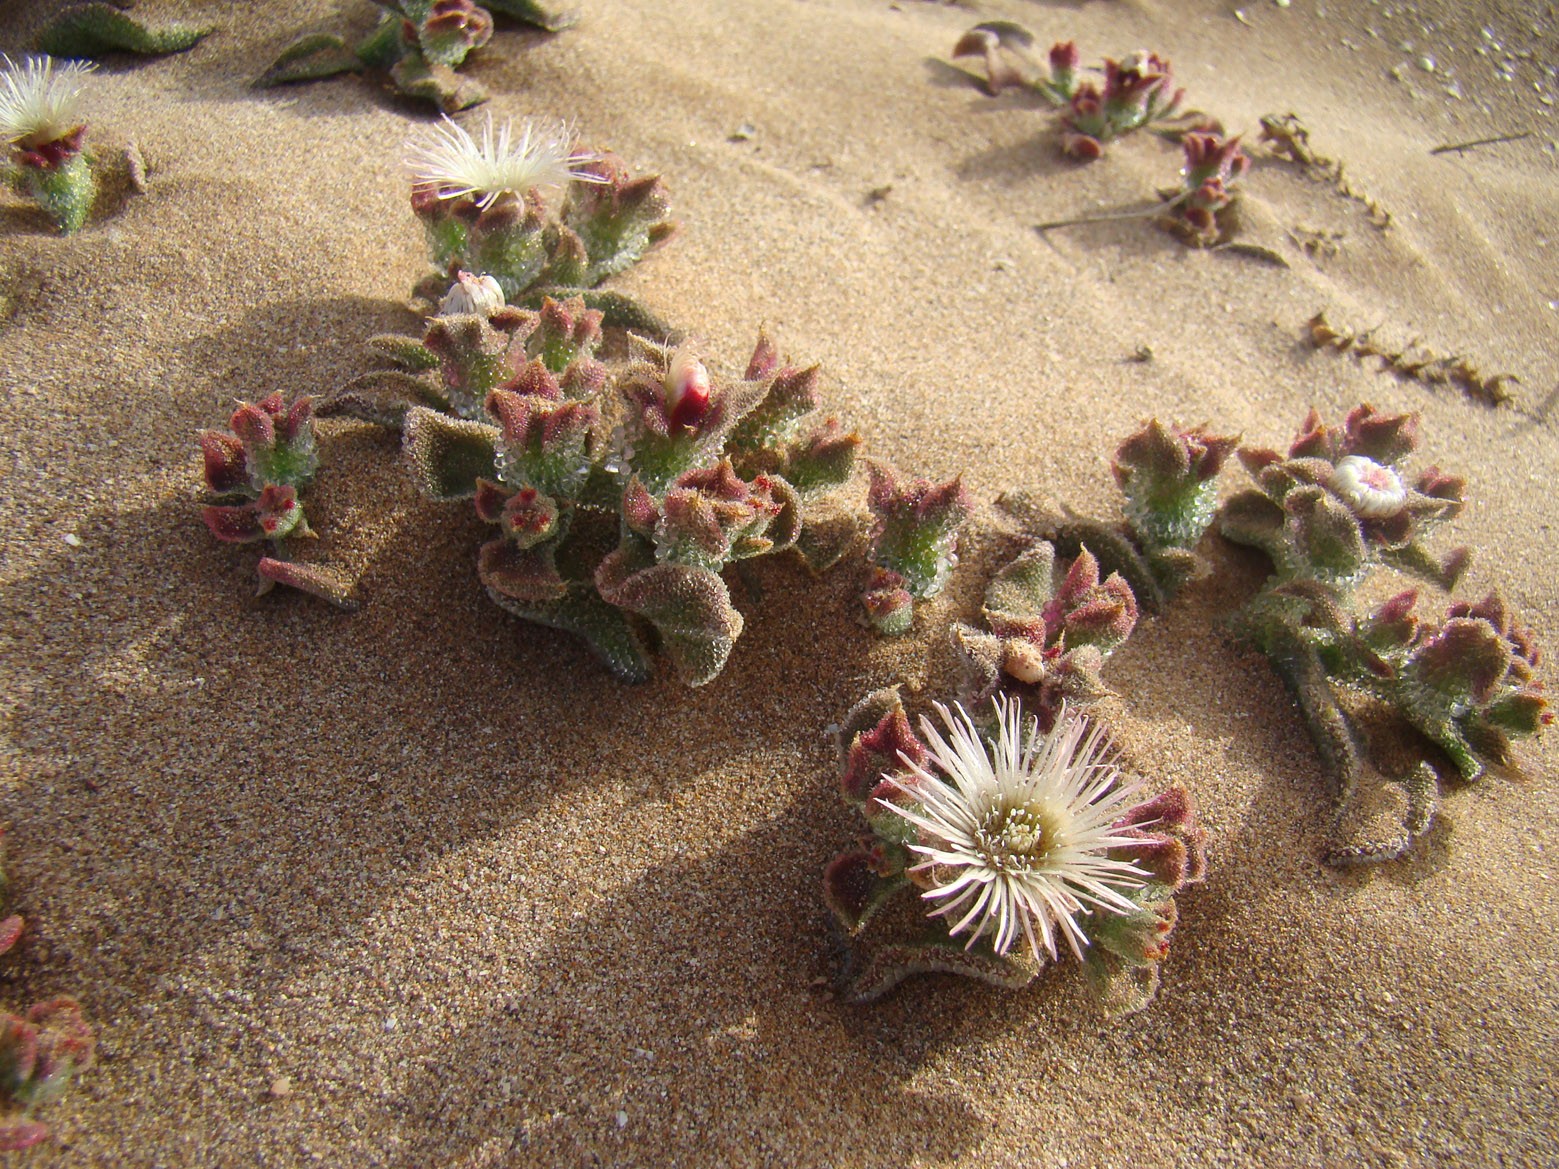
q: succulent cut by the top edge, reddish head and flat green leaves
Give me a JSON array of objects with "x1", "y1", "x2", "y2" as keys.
[{"x1": 254, "y1": 0, "x2": 574, "y2": 114}]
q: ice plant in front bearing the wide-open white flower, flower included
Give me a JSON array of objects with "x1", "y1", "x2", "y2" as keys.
[{"x1": 825, "y1": 690, "x2": 1205, "y2": 1013}]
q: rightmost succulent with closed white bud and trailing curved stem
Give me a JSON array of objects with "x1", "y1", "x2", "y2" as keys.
[{"x1": 1219, "y1": 405, "x2": 1553, "y2": 864}]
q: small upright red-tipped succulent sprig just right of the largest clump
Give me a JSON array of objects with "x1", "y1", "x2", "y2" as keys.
[{"x1": 861, "y1": 460, "x2": 974, "y2": 636}]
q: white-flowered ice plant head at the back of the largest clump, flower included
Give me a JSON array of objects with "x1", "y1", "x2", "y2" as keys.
[{"x1": 405, "y1": 115, "x2": 675, "y2": 317}]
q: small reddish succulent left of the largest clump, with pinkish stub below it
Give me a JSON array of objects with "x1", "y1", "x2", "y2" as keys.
[{"x1": 200, "y1": 393, "x2": 355, "y2": 609}]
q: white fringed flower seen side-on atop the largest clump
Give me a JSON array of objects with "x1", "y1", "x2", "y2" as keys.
[{"x1": 405, "y1": 114, "x2": 605, "y2": 207}]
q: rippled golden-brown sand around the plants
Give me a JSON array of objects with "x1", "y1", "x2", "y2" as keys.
[{"x1": 0, "y1": 0, "x2": 1559, "y2": 1169}]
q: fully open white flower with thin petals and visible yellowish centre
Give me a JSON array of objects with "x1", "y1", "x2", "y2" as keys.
[{"x1": 879, "y1": 697, "x2": 1147, "y2": 962}]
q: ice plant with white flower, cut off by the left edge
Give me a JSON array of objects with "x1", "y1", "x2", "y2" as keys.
[{"x1": 0, "y1": 56, "x2": 97, "y2": 234}]
